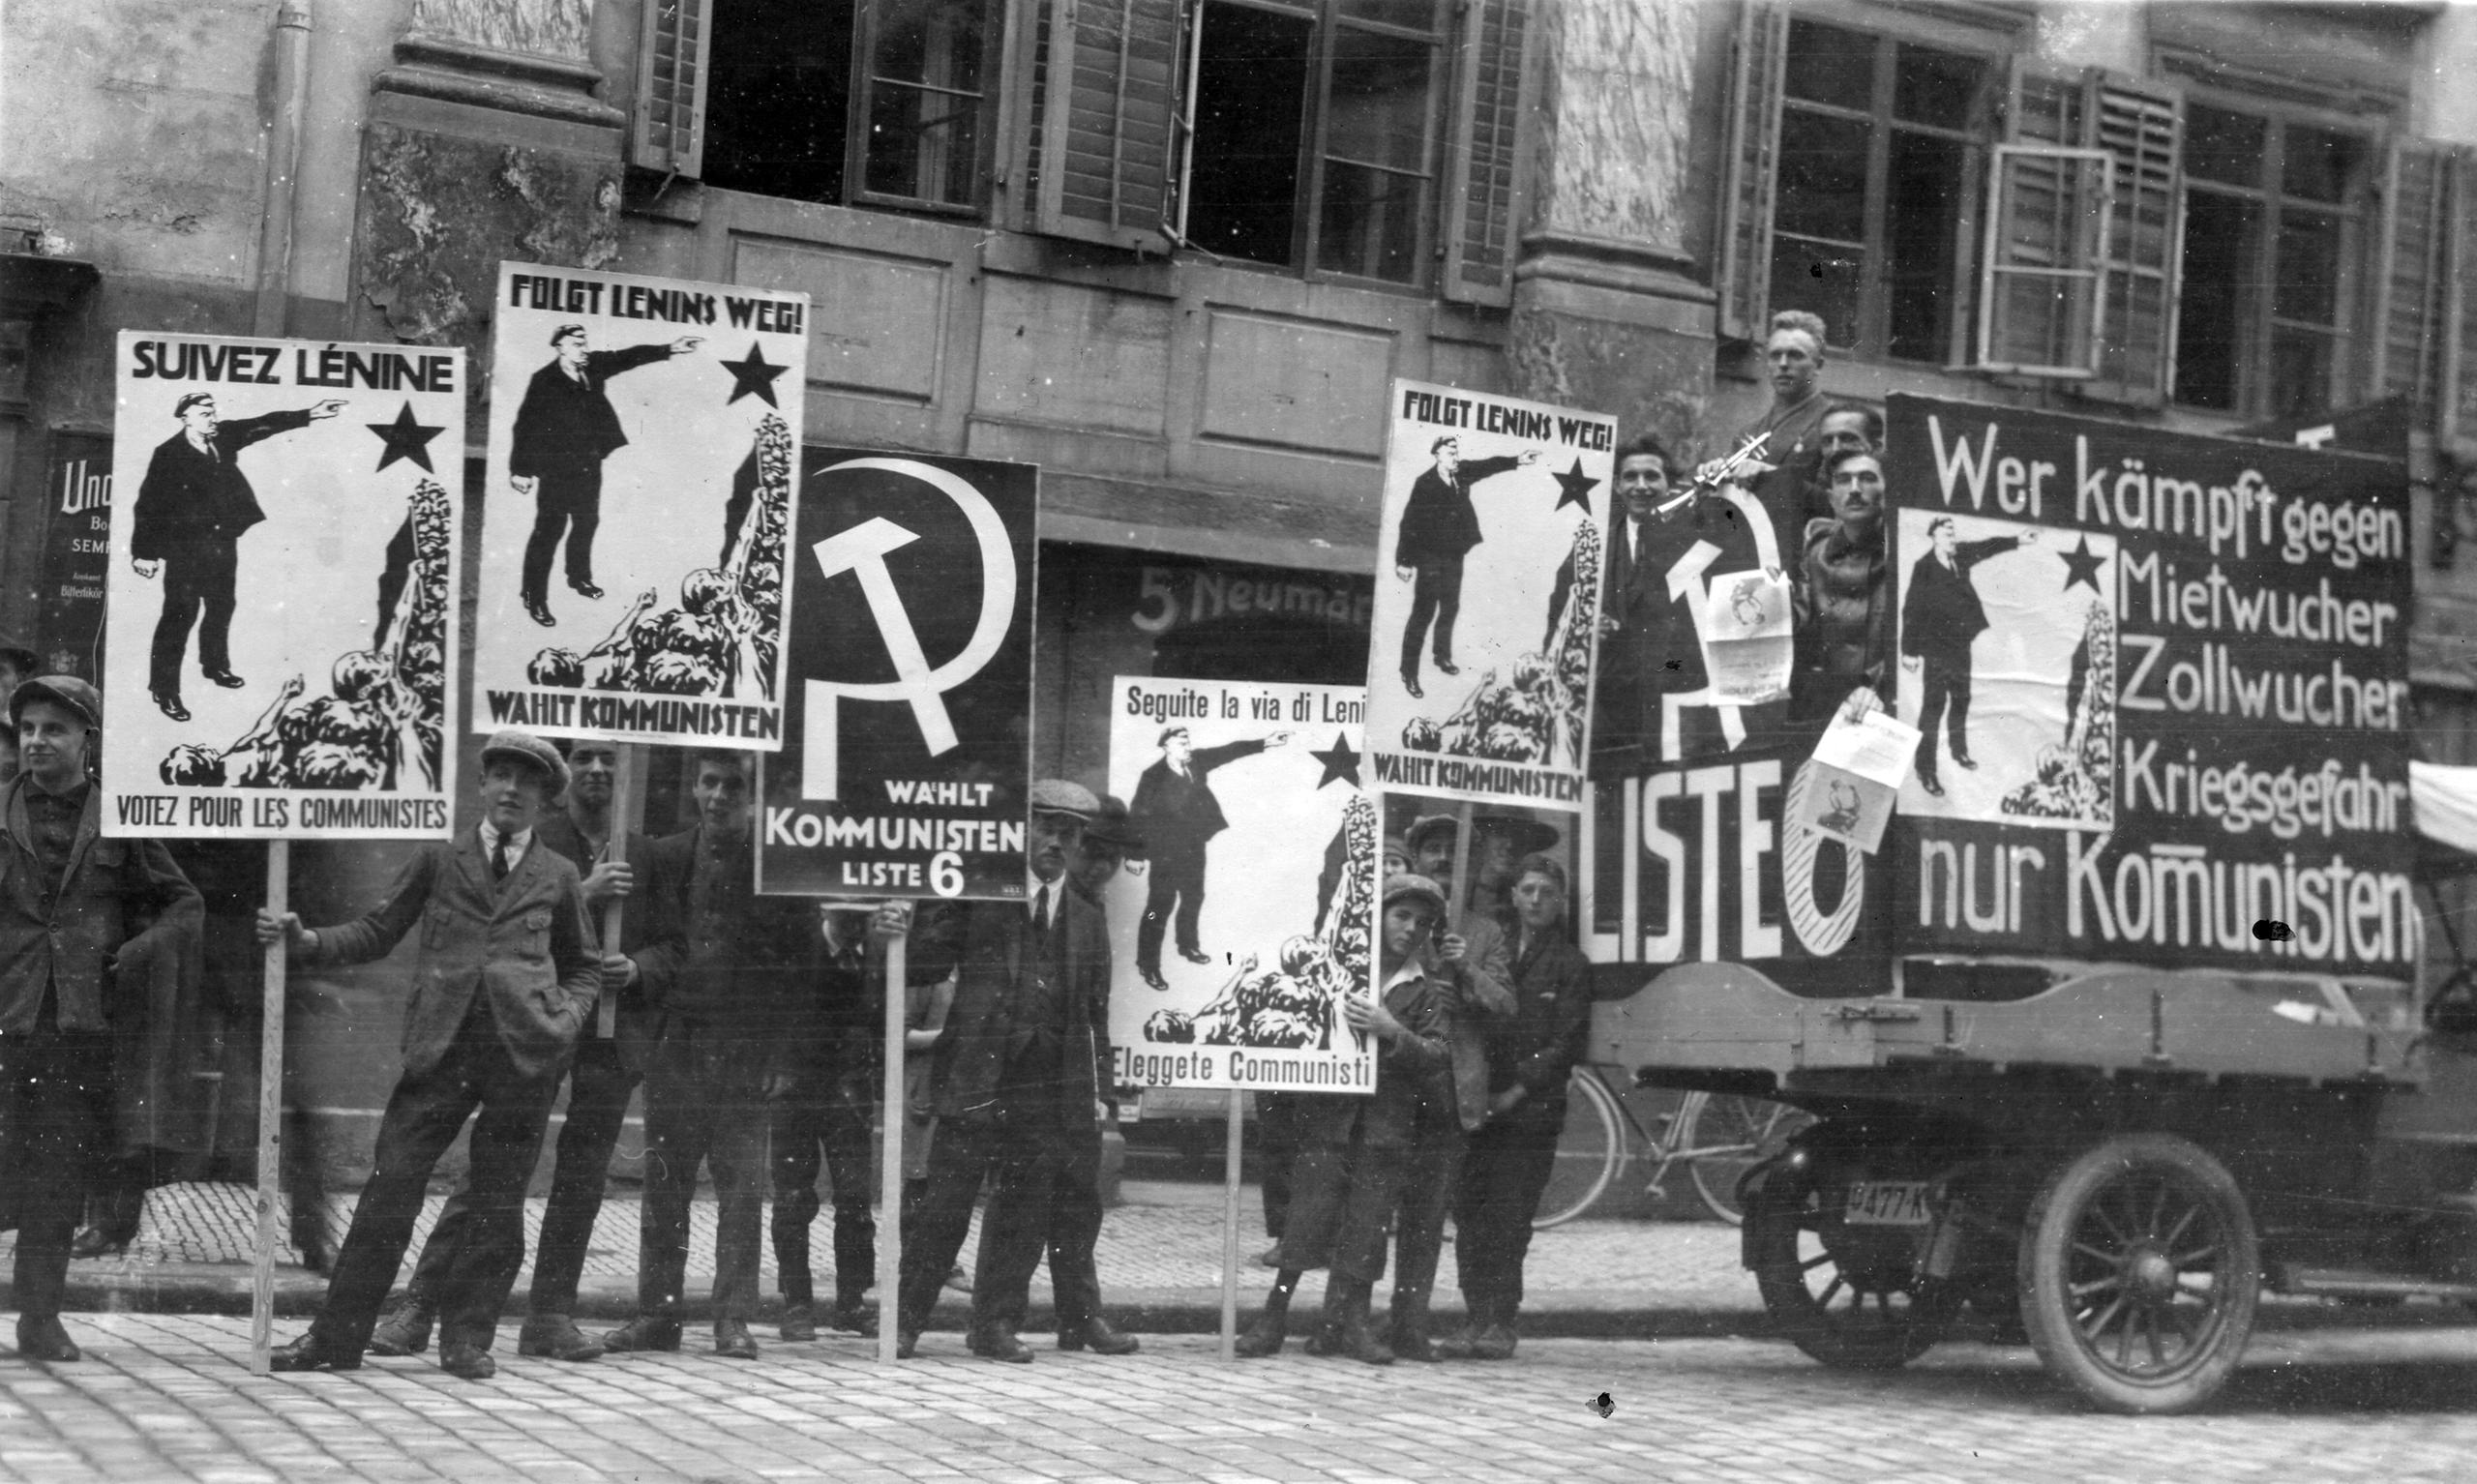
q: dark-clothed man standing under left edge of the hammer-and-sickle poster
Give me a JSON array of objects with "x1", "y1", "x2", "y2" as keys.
[{"x1": 602, "y1": 751, "x2": 818, "y2": 1360}]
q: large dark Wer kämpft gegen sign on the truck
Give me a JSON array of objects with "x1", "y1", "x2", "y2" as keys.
[{"x1": 1888, "y1": 397, "x2": 2418, "y2": 973}]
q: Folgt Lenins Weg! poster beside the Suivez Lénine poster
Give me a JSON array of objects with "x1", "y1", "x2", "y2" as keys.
[{"x1": 473, "y1": 262, "x2": 808, "y2": 751}]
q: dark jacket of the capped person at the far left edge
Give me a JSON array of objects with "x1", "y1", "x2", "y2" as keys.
[{"x1": 0, "y1": 776, "x2": 200, "y2": 1035}]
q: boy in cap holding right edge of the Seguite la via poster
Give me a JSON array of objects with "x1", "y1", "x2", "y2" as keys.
[{"x1": 1238, "y1": 875, "x2": 1456, "y2": 1365}]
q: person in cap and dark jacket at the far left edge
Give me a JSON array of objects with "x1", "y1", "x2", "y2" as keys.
[{"x1": 0, "y1": 676, "x2": 198, "y2": 1360}]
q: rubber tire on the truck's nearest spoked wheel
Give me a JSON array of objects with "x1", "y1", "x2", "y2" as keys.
[{"x1": 2018, "y1": 1135, "x2": 2261, "y2": 1414}]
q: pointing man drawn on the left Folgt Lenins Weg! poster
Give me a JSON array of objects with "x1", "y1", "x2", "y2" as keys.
[{"x1": 508, "y1": 324, "x2": 703, "y2": 627}]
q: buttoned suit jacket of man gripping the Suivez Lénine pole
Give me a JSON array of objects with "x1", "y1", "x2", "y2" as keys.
[{"x1": 310, "y1": 827, "x2": 602, "y2": 1078}]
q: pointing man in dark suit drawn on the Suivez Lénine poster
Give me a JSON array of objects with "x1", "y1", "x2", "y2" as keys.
[{"x1": 129, "y1": 392, "x2": 344, "y2": 721}]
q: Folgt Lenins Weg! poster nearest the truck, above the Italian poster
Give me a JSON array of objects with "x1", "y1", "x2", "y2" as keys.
[{"x1": 1367, "y1": 381, "x2": 1618, "y2": 810}]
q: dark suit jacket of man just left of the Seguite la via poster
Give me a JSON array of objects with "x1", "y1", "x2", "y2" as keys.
[{"x1": 907, "y1": 892, "x2": 1110, "y2": 1120}]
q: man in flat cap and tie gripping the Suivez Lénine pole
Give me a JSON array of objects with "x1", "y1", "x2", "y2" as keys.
[{"x1": 257, "y1": 730, "x2": 602, "y2": 1380}]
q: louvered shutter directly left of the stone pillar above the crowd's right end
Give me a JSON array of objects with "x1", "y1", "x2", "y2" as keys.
[{"x1": 1439, "y1": 0, "x2": 1536, "y2": 305}]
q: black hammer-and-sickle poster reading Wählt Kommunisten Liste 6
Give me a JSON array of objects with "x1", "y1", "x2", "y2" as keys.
[{"x1": 758, "y1": 449, "x2": 1040, "y2": 902}]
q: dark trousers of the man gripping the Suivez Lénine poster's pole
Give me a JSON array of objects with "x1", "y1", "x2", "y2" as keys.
[{"x1": 310, "y1": 995, "x2": 560, "y2": 1355}]
